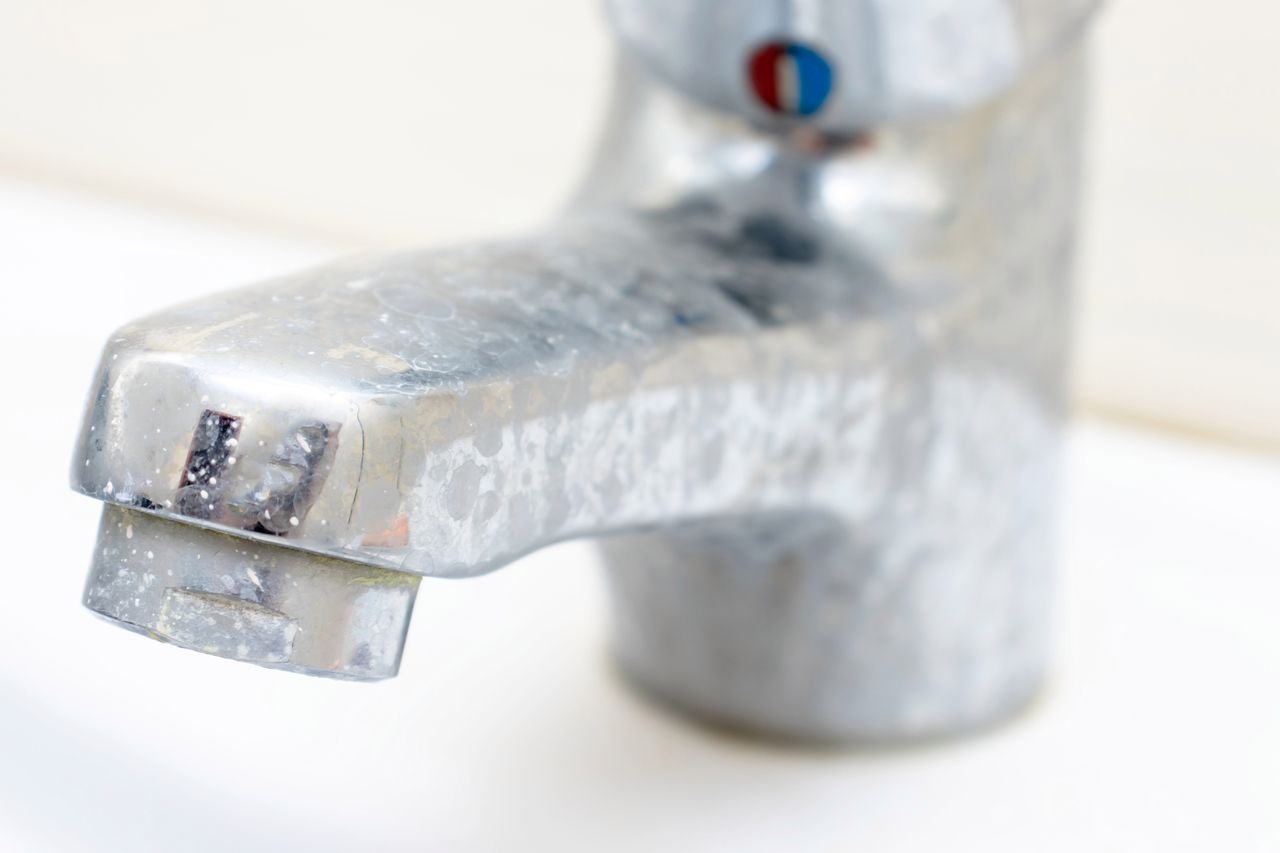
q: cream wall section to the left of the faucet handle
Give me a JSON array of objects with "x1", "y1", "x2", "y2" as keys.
[{"x1": 0, "y1": 0, "x2": 609, "y2": 243}]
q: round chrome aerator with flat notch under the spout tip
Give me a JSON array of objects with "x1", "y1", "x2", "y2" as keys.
[{"x1": 84, "y1": 505, "x2": 419, "y2": 680}]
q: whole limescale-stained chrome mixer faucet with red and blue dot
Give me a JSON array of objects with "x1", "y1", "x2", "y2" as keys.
[{"x1": 72, "y1": 0, "x2": 1093, "y2": 742}]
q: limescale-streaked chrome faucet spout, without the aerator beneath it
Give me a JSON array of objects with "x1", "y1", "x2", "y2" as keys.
[{"x1": 76, "y1": 211, "x2": 890, "y2": 576}]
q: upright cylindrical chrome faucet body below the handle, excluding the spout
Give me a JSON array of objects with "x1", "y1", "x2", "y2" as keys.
[{"x1": 590, "y1": 23, "x2": 1084, "y2": 740}]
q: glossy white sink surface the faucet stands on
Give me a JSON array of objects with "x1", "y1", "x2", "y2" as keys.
[{"x1": 0, "y1": 178, "x2": 1280, "y2": 852}]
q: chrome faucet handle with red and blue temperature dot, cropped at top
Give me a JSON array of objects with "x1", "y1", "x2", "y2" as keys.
[{"x1": 605, "y1": 0, "x2": 1098, "y2": 133}]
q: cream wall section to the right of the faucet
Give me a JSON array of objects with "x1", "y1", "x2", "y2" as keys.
[{"x1": 1078, "y1": 0, "x2": 1280, "y2": 448}]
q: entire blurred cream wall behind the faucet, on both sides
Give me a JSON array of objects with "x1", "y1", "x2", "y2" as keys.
[{"x1": 0, "y1": 0, "x2": 1280, "y2": 447}]
